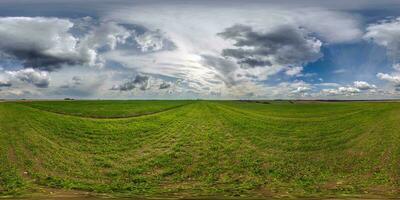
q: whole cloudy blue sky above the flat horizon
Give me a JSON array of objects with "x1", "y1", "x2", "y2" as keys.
[{"x1": 0, "y1": 0, "x2": 400, "y2": 99}]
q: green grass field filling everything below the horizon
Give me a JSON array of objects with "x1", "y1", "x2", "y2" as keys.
[{"x1": 0, "y1": 101, "x2": 400, "y2": 197}]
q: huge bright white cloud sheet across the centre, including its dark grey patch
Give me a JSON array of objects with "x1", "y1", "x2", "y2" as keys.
[{"x1": 107, "y1": 3, "x2": 362, "y2": 96}]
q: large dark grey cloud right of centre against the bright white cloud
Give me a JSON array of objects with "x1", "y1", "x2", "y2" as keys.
[{"x1": 218, "y1": 24, "x2": 321, "y2": 68}]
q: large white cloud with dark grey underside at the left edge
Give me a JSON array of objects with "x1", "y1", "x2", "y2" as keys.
[{"x1": 0, "y1": 17, "x2": 95, "y2": 71}]
